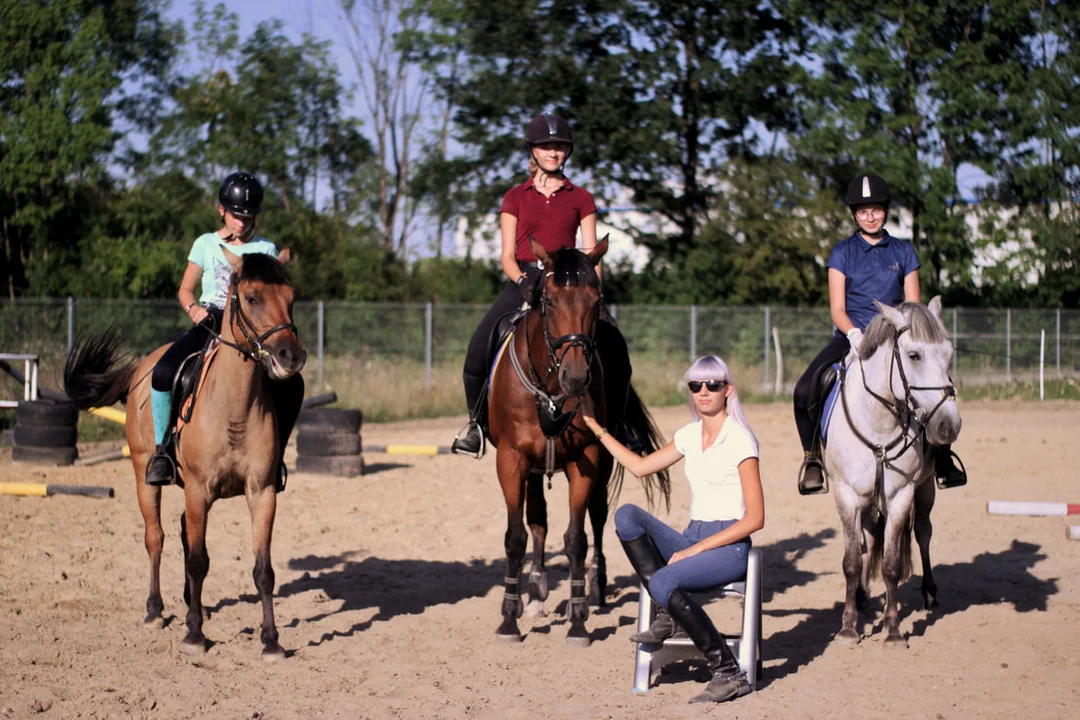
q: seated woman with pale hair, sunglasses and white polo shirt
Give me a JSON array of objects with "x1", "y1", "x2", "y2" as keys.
[{"x1": 584, "y1": 355, "x2": 765, "y2": 703}]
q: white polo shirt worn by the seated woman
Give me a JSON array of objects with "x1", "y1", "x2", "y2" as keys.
[{"x1": 674, "y1": 418, "x2": 758, "y2": 520}]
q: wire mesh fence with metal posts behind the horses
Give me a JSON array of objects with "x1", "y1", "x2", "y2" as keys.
[{"x1": 0, "y1": 298, "x2": 1080, "y2": 419}]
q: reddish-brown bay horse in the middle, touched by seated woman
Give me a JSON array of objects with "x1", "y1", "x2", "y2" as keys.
[{"x1": 488, "y1": 237, "x2": 670, "y2": 647}]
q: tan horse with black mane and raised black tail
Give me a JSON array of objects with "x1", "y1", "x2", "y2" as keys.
[{"x1": 64, "y1": 249, "x2": 307, "y2": 661}]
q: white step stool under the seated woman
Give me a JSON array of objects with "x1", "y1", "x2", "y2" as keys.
[{"x1": 633, "y1": 547, "x2": 761, "y2": 695}]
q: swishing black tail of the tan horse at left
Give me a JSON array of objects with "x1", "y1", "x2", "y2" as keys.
[{"x1": 64, "y1": 329, "x2": 136, "y2": 410}]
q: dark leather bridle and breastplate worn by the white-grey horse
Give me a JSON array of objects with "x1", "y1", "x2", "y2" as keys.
[{"x1": 840, "y1": 325, "x2": 956, "y2": 513}]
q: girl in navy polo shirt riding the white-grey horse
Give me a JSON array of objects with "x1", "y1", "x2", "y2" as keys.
[{"x1": 795, "y1": 173, "x2": 967, "y2": 494}]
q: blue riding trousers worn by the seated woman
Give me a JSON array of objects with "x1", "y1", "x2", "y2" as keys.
[{"x1": 615, "y1": 504, "x2": 751, "y2": 610}]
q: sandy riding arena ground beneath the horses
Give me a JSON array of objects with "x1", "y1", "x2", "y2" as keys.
[{"x1": 0, "y1": 403, "x2": 1080, "y2": 719}]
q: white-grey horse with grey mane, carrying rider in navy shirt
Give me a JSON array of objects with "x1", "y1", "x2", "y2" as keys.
[{"x1": 825, "y1": 297, "x2": 960, "y2": 647}]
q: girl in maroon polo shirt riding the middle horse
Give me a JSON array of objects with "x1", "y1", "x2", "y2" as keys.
[{"x1": 450, "y1": 112, "x2": 630, "y2": 458}]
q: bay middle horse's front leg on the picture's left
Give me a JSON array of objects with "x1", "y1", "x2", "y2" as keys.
[{"x1": 495, "y1": 446, "x2": 528, "y2": 642}]
